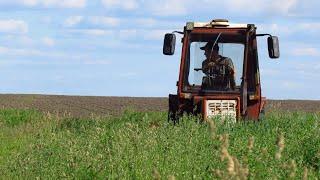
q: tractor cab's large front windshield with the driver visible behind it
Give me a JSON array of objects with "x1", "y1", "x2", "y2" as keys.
[{"x1": 185, "y1": 34, "x2": 245, "y2": 91}]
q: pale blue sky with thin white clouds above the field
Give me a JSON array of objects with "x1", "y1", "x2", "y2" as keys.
[{"x1": 0, "y1": 0, "x2": 320, "y2": 100}]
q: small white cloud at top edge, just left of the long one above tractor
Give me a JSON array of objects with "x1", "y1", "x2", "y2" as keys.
[{"x1": 101, "y1": 0, "x2": 139, "y2": 10}]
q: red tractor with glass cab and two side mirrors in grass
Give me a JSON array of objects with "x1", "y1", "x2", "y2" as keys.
[{"x1": 163, "y1": 19, "x2": 280, "y2": 122}]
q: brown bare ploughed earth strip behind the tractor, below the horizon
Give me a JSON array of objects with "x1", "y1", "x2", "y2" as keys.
[{"x1": 0, "y1": 94, "x2": 320, "y2": 117}]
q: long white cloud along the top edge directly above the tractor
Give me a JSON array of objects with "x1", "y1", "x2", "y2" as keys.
[{"x1": 141, "y1": 0, "x2": 299, "y2": 17}]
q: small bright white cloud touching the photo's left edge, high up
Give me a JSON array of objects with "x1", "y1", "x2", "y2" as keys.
[{"x1": 0, "y1": 19, "x2": 28, "y2": 34}]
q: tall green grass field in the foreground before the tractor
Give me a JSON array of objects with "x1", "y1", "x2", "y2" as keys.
[{"x1": 0, "y1": 109, "x2": 320, "y2": 179}]
